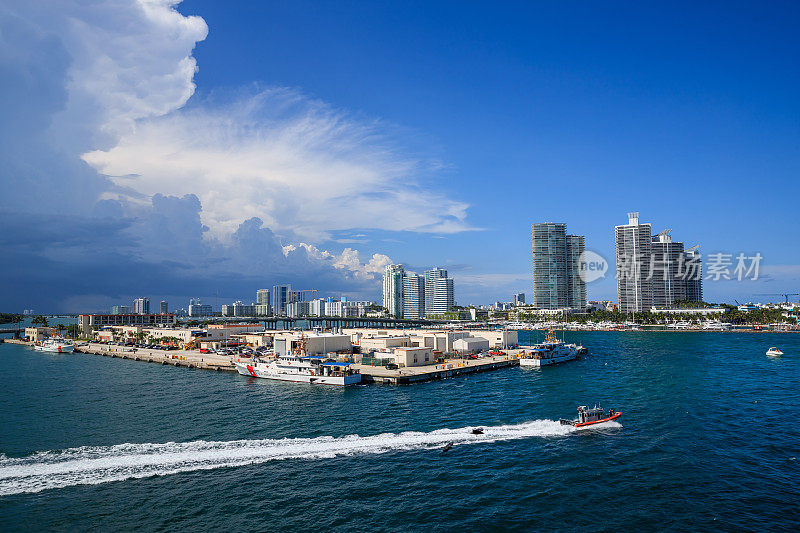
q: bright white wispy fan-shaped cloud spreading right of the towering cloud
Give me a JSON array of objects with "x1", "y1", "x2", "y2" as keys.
[{"x1": 84, "y1": 88, "x2": 471, "y2": 242}]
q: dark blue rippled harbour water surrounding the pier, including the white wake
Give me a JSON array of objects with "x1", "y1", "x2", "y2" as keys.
[{"x1": 0, "y1": 332, "x2": 800, "y2": 531}]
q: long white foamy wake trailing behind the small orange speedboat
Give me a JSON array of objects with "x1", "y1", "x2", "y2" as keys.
[{"x1": 0, "y1": 420, "x2": 620, "y2": 496}]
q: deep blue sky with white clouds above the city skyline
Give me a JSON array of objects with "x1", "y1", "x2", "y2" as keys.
[{"x1": 0, "y1": 0, "x2": 800, "y2": 310}]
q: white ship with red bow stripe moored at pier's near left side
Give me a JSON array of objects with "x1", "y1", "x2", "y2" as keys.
[{"x1": 234, "y1": 355, "x2": 361, "y2": 386}]
